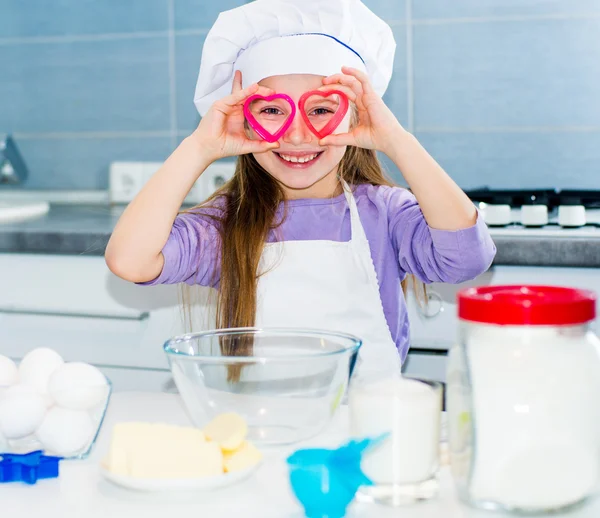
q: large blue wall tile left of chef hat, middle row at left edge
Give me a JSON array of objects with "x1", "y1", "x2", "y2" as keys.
[{"x1": 0, "y1": 37, "x2": 169, "y2": 133}]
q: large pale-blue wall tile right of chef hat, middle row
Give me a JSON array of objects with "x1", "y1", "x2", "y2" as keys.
[{"x1": 414, "y1": 18, "x2": 600, "y2": 129}]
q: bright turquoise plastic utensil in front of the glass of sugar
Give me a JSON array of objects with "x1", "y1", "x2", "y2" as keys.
[{"x1": 287, "y1": 434, "x2": 389, "y2": 518}]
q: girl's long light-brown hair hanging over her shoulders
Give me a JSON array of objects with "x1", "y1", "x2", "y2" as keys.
[{"x1": 184, "y1": 146, "x2": 426, "y2": 364}]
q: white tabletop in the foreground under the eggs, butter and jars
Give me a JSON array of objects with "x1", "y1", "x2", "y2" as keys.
[{"x1": 0, "y1": 392, "x2": 600, "y2": 518}]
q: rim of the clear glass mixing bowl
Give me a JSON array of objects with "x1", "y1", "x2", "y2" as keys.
[{"x1": 163, "y1": 327, "x2": 363, "y2": 364}]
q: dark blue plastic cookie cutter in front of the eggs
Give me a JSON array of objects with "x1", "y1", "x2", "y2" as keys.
[{"x1": 0, "y1": 451, "x2": 62, "y2": 484}]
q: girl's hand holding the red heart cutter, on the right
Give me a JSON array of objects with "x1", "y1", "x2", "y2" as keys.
[{"x1": 319, "y1": 67, "x2": 406, "y2": 155}]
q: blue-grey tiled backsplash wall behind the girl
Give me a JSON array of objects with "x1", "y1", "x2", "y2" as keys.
[{"x1": 0, "y1": 0, "x2": 600, "y2": 189}]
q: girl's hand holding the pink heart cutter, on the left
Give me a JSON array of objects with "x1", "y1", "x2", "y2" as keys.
[{"x1": 192, "y1": 71, "x2": 279, "y2": 162}]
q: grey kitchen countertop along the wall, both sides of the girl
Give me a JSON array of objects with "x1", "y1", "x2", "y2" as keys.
[{"x1": 0, "y1": 205, "x2": 600, "y2": 267}]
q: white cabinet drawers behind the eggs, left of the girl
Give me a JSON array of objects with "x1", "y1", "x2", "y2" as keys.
[{"x1": 0, "y1": 254, "x2": 214, "y2": 390}]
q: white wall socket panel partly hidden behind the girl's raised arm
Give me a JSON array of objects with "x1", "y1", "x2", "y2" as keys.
[{"x1": 109, "y1": 161, "x2": 235, "y2": 204}]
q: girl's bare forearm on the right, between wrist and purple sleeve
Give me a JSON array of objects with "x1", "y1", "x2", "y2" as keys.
[{"x1": 386, "y1": 128, "x2": 477, "y2": 230}]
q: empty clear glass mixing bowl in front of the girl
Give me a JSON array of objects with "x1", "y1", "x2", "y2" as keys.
[{"x1": 164, "y1": 328, "x2": 362, "y2": 445}]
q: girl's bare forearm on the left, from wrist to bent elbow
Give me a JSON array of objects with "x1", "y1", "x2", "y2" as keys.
[{"x1": 105, "y1": 137, "x2": 211, "y2": 282}]
